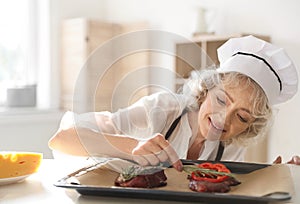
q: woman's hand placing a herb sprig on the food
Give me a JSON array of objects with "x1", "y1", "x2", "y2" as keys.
[{"x1": 132, "y1": 133, "x2": 183, "y2": 171}]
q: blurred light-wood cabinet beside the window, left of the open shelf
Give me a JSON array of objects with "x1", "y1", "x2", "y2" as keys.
[{"x1": 60, "y1": 18, "x2": 148, "y2": 112}]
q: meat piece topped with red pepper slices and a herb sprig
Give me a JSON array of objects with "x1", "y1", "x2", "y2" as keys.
[{"x1": 184, "y1": 162, "x2": 241, "y2": 193}]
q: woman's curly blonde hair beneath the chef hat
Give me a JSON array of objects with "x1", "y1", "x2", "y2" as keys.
[{"x1": 181, "y1": 69, "x2": 273, "y2": 145}]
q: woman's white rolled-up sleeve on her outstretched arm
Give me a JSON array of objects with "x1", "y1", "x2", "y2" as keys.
[{"x1": 61, "y1": 92, "x2": 187, "y2": 139}]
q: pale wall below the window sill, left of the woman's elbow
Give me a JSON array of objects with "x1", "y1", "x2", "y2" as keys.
[{"x1": 0, "y1": 109, "x2": 62, "y2": 158}]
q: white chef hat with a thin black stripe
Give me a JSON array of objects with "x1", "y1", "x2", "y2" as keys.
[{"x1": 217, "y1": 35, "x2": 298, "y2": 105}]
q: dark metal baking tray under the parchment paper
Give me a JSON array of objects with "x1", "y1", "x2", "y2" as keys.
[{"x1": 54, "y1": 160, "x2": 291, "y2": 204}]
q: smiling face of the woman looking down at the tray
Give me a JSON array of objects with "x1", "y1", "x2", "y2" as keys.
[{"x1": 198, "y1": 79, "x2": 255, "y2": 140}]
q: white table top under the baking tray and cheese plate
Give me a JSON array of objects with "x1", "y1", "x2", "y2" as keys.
[{"x1": 0, "y1": 160, "x2": 300, "y2": 204}]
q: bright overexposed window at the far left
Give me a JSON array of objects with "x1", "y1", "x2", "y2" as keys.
[{"x1": 0, "y1": 0, "x2": 50, "y2": 108}]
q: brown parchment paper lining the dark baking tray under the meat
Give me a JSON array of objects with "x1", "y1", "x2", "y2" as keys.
[{"x1": 70, "y1": 164, "x2": 294, "y2": 197}]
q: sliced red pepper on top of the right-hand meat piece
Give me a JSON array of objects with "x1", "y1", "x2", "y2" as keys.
[{"x1": 191, "y1": 162, "x2": 231, "y2": 183}]
